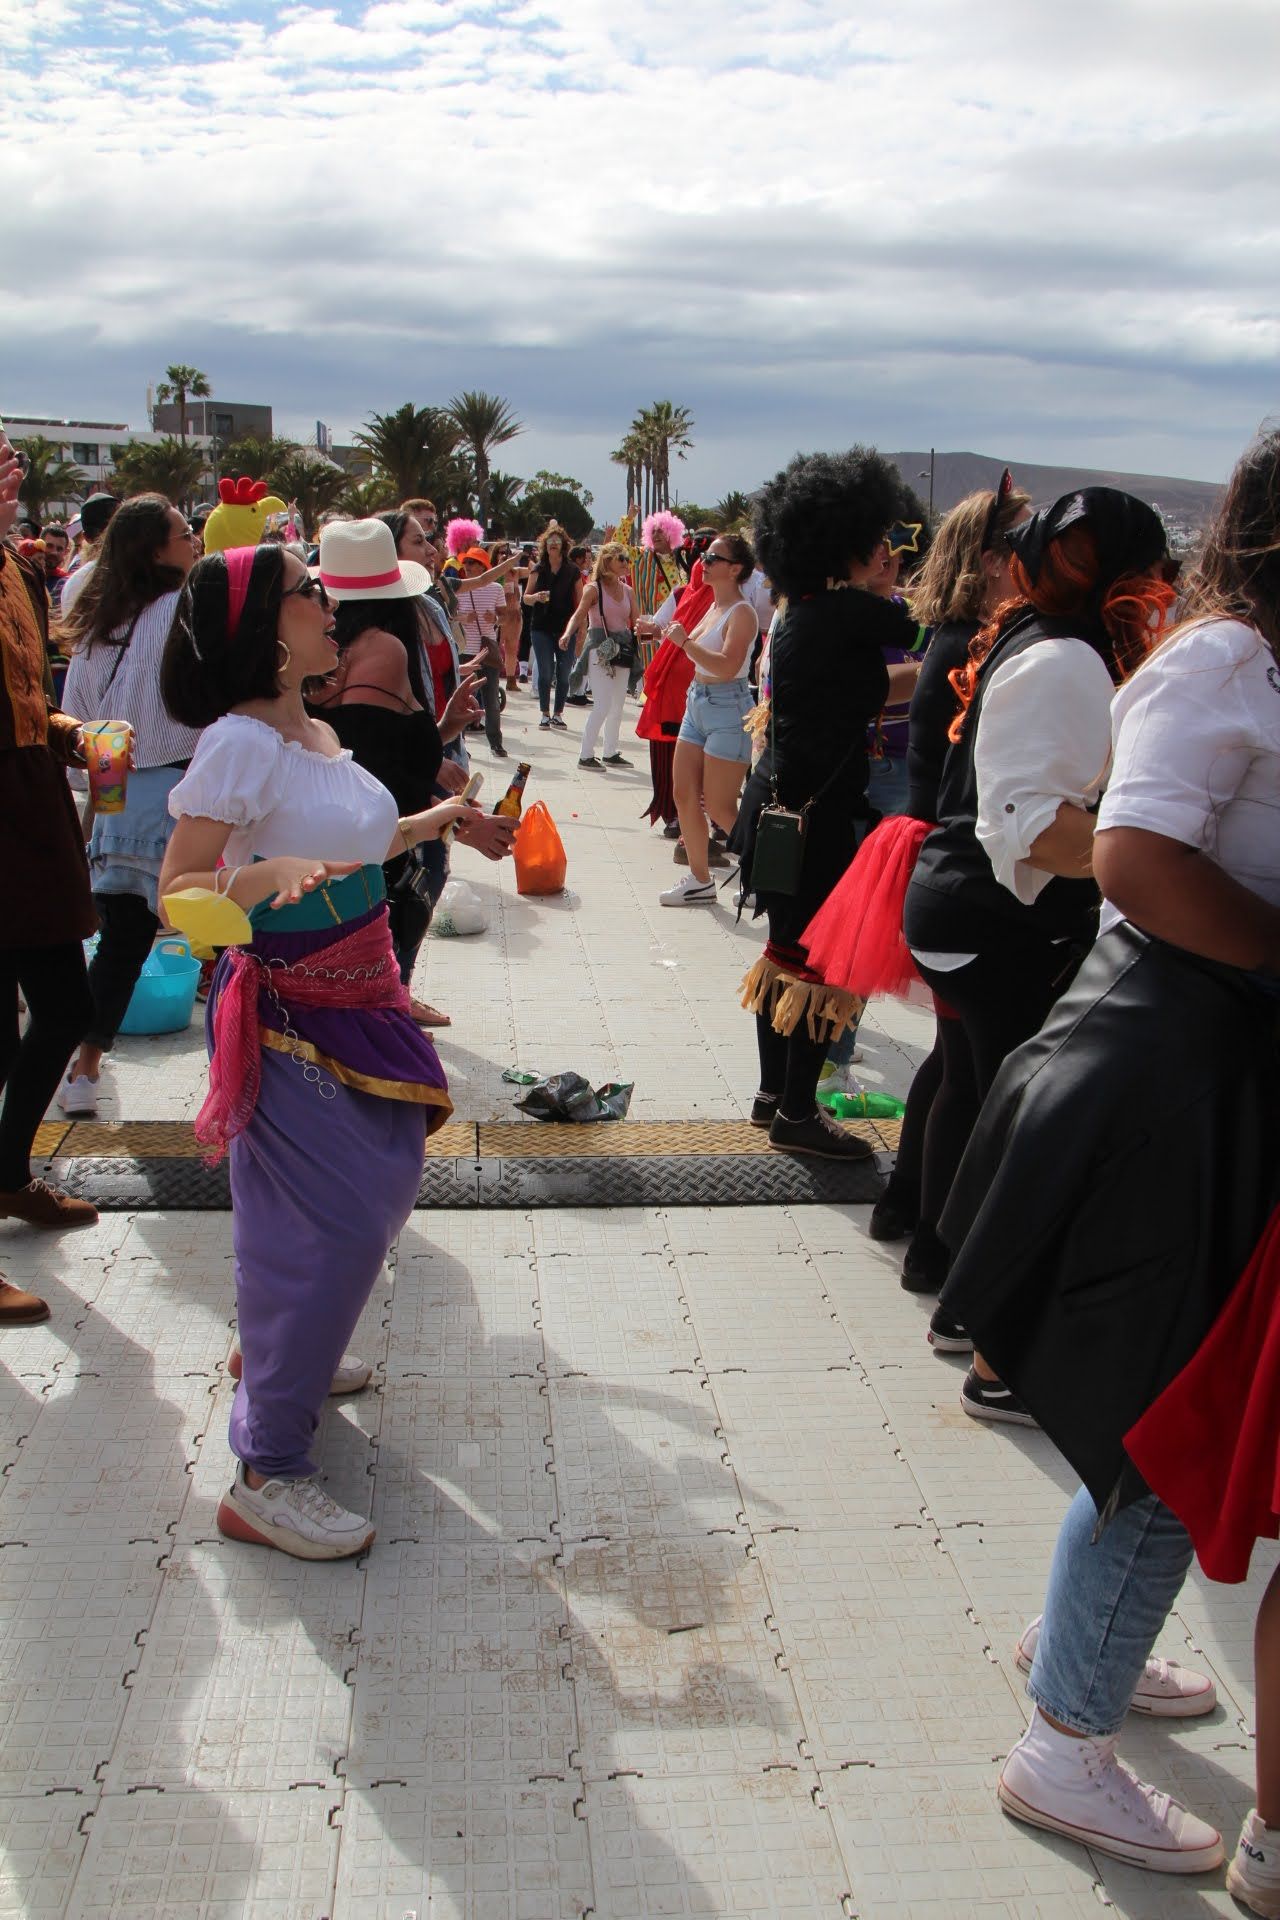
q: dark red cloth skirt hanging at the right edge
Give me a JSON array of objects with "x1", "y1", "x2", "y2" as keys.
[{"x1": 1125, "y1": 1210, "x2": 1280, "y2": 1582}]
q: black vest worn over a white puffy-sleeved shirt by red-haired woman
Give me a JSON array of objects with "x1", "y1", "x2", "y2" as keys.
[{"x1": 904, "y1": 611, "x2": 1111, "y2": 952}]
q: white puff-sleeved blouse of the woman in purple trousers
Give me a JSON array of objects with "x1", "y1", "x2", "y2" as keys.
[{"x1": 169, "y1": 714, "x2": 399, "y2": 866}]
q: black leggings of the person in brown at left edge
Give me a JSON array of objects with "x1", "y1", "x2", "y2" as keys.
[{"x1": 0, "y1": 941, "x2": 94, "y2": 1192}]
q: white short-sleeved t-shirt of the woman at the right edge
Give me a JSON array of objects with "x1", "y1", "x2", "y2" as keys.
[{"x1": 1098, "y1": 620, "x2": 1280, "y2": 929}]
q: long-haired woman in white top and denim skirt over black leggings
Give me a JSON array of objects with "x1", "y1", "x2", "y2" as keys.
[{"x1": 58, "y1": 493, "x2": 200, "y2": 1117}]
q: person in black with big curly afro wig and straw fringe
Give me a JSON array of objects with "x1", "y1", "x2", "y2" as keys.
[{"x1": 733, "y1": 447, "x2": 919, "y2": 1160}]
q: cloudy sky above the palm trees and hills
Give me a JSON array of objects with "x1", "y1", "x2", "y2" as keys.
[{"x1": 0, "y1": 0, "x2": 1280, "y2": 507}]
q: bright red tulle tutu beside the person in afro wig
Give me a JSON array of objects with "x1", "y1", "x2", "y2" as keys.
[{"x1": 804, "y1": 814, "x2": 933, "y2": 1006}]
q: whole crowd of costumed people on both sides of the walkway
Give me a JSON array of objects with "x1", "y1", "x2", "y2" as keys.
[{"x1": 0, "y1": 434, "x2": 1280, "y2": 1916}]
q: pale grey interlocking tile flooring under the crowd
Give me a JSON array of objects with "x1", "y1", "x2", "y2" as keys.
[{"x1": 0, "y1": 697, "x2": 1274, "y2": 1920}]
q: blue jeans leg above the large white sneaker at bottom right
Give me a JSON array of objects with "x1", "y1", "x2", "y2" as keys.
[{"x1": 1027, "y1": 1488, "x2": 1192, "y2": 1740}]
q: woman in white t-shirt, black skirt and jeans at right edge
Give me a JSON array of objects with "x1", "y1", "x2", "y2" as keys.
[{"x1": 942, "y1": 432, "x2": 1280, "y2": 1914}]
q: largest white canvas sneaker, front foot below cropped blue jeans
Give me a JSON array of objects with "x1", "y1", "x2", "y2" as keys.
[{"x1": 996, "y1": 1711, "x2": 1222, "y2": 1874}]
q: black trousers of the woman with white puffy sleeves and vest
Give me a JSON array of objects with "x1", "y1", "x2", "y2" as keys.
[{"x1": 917, "y1": 945, "x2": 1084, "y2": 1227}]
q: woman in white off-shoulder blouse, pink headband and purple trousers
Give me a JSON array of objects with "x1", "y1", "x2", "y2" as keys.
[{"x1": 161, "y1": 528, "x2": 510, "y2": 1559}]
